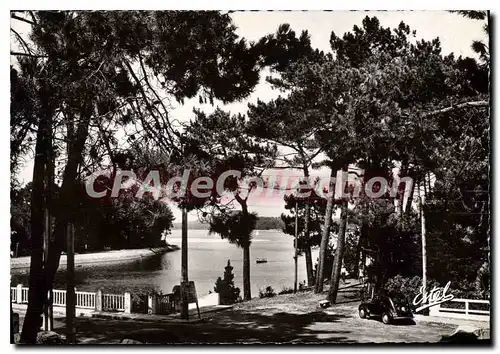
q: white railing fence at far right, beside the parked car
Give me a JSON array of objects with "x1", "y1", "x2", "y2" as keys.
[{"x1": 429, "y1": 299, "x2": 491, "y2": 321}]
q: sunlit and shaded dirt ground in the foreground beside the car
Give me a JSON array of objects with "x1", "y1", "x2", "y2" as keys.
[{"x1": 15, "y1": 280, "x2": 484, "y2": 344}]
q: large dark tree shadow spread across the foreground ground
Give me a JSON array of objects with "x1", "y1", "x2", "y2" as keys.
[{"x1": 61, "y1": 311, "x2": 357, "y2": 344}]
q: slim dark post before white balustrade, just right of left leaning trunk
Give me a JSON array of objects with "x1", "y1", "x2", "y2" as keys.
[{"x1": 66, "y1": 223, "x2": 76, "y2": 343}]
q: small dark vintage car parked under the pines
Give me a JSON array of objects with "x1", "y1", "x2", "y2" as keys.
[{"x1": 358, "y1": 295, "x2": 413, "y2": 324}]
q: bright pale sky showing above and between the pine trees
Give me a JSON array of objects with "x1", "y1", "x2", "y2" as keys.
[{"x1": 13, "y1": 11, "x2": 487, "y2": 222}]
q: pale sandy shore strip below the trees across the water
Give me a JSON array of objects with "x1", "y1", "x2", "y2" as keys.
[{"x1": 10, "y1": 245, "x2": 179, "y2": 273}]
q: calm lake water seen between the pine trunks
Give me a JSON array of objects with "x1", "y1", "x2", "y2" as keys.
[{"x1": 11, "y1": 230, "x2": 317, "y2": 297}]
